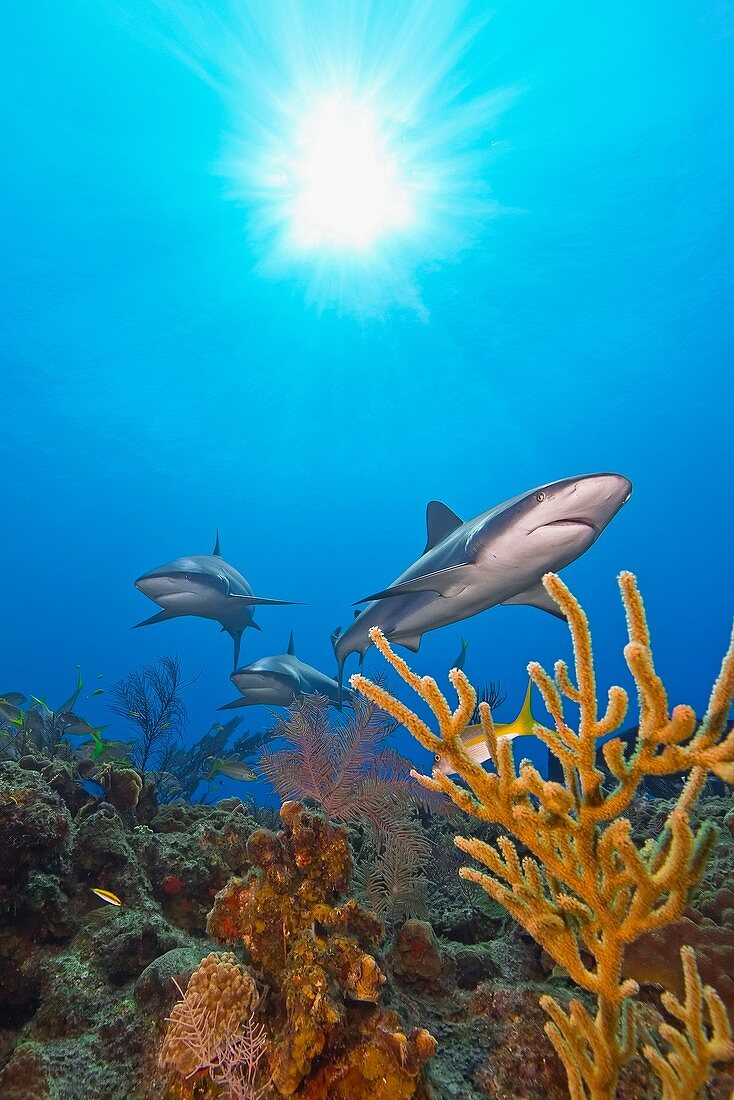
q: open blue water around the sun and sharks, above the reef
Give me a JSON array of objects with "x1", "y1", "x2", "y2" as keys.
[{"x1": 0, "y1": 0, "x2": 734, "y2": 805}]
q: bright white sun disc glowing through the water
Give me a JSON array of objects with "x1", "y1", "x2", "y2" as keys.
[{"x1": 289, "y1": 95, "x2": 412, "y2": 252}]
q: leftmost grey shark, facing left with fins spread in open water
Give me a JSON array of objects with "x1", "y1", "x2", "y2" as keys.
[{"x1": 135, "y1": 531, "x2": 293, "y2": 668}]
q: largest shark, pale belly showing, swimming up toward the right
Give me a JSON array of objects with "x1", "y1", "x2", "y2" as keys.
[{"x1": 332, "y1": 474, "x2": 632, "y2": 683}]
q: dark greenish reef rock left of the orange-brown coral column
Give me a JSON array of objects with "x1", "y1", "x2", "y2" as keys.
[{"x1": 0, "y1": 761, "x2": 263, "y2": 1100}]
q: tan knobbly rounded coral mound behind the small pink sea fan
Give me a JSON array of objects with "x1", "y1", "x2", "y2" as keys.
[{"x1": 158, "y1": 952, "x2": 259, "y2": 1077}]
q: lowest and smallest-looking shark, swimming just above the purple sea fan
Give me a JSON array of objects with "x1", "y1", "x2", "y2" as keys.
[{"x1": 219, "y1": 631, "x2": 354, "y2": 711}]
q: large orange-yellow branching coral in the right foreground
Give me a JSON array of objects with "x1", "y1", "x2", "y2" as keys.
[{"x1": 351, "y1": 573, "x2": 734, "y2": 1100}]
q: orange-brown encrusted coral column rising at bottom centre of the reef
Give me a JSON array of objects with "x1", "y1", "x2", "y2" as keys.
[{"x1": 208, "y1": 802, "x2": 436, "y2": 1100}]
